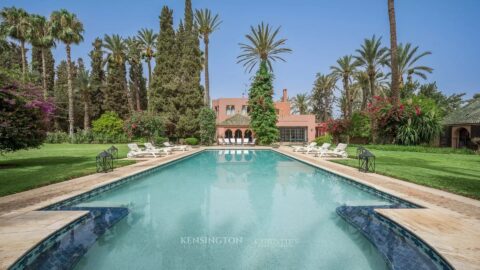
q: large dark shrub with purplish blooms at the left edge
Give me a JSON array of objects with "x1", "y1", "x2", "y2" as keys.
[{"x1": 0, "y1": 86, "x2": 53, "y2": 153}]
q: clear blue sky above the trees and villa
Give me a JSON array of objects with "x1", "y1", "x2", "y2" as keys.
[{"x1": 1, "y1": 0, "x2": 480, "y2": 98}]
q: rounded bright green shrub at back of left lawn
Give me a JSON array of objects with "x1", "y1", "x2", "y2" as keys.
[{"x1": 92, "y1": 112, "x2": 125, "y2": 138}]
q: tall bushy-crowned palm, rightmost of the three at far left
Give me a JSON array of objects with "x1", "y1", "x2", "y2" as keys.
[{"x1": 50, "y1": 9, "x2": 84, "y2": 138}]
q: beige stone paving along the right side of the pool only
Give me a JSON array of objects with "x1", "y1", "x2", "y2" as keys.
[{"x1": 276, "y1": 146, "x2": 480, "y2": 270}]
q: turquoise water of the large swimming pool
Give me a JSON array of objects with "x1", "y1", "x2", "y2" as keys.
[{"x1": 76, "y1": 150, "x2": 390, "y2": 269}]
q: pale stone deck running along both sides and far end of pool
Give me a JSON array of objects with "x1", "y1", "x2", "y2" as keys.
[{"x1": 0, "y1": 146, "x2": 480, "y2": 269}]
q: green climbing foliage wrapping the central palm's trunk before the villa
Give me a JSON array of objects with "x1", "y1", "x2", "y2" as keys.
[{"x1": 248, "y1": 61, "x2": 279, "y2": 145}]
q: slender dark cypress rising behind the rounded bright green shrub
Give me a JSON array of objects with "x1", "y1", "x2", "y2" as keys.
[{"x1": 89, "y1": 38, "x2": 105, "y2": 119}]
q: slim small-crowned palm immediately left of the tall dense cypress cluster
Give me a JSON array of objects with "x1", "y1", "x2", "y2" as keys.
[{"x1": 138, "y1": 28, "x2": 158, "y2": 111}]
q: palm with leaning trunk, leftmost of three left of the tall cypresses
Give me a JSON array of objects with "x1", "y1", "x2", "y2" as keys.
[{"x1": 104, "y1": 34, "x2": 135, "y2": 112}]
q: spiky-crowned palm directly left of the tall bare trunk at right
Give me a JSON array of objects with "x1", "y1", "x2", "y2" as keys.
[{"x1": 355, "y1": 35, "x2": 388, "y2": 143}]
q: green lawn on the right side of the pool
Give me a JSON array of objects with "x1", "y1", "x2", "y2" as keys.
[{"x1": 333, "y1": 146, "x2": 480, "y2": 199}]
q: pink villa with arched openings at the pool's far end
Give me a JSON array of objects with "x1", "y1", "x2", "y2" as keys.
[{"x1": 212, "y1": 89, "x2": 322, "y2": 143}]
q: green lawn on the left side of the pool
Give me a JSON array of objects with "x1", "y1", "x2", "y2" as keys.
[{"x1": 0, "y1": 144, "x2": 135, "y2": 196}]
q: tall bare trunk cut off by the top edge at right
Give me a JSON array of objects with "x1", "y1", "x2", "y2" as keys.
[{"x1": 387, "y1": 0, "x2": 400, "y2": 106}]
